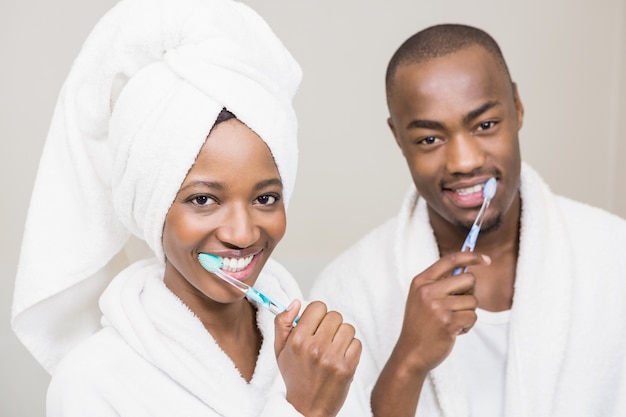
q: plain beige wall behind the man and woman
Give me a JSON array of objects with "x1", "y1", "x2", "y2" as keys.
[{"x1": 0, "y1": 0, "x2": 626, "y2": 417}]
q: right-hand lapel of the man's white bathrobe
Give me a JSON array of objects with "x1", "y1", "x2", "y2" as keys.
[{"x1": 506, "y1": 166, "x2": 575, "y2": 417}]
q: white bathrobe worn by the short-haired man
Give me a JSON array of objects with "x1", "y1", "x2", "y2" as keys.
[{"x1": 312, "y1": 165, "x2": 626, "y2": 417}]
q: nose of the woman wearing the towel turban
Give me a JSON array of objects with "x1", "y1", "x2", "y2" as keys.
[{"x1": 216, "y1": 206, "x2": 260, "y2": 248}]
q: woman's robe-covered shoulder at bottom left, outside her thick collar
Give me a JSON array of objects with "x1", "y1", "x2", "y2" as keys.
[{"x1": 46, "y1": 327, "x2": 187, "y2": 417}]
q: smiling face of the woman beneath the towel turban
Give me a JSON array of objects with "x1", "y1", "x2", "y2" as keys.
[{"x1": 163, "y1": 119, "x2": 286, "y2": 304}]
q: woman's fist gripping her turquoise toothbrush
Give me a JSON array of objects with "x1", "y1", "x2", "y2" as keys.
[{"x1": 274, "y1": 300, "x2": 362, "y2": 417}]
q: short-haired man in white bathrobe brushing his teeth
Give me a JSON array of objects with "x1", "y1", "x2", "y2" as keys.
[{"x1": 312, "y1": 25, "x2": 626, "y2": 417}]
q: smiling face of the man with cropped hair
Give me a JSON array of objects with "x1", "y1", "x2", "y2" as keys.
[{"x1": 388, "y1": 46, "x2": 523, "y2": 234}]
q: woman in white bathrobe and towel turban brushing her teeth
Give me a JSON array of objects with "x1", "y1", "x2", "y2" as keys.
[{"x1": 13, "y1": 0, "x2": 361, "y2": 417}]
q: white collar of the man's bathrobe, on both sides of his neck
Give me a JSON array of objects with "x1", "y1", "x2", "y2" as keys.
[{"x1": 394, "y1": 165, "x2": 573, "y2": 417}]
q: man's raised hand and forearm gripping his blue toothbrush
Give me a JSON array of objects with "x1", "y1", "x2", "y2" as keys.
[{"x1": 372, "y1": 252, "x2": 491, "y2": 417}]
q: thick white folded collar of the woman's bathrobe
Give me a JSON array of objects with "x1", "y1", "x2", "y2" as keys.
[{"x1": 102, "y1": 263, "x2": 278, "y2": 416}]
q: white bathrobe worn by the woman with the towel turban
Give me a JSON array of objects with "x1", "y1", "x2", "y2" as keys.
[{"x1": 48, "y1": 259, "x2": 302, "y2": 417}]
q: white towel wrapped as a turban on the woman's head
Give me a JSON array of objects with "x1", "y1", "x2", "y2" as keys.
[{"x1": 12, "y1": 0, "x2": 301, "y2": 372}]
